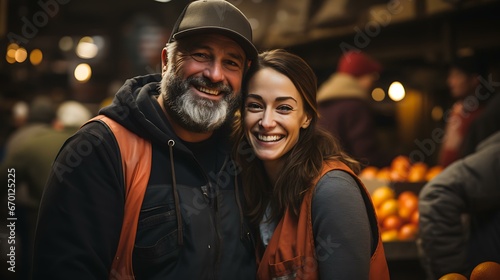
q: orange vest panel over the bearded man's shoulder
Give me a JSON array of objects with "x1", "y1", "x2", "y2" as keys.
[{"x1": 88, "y1": 115, "x2": 152, "y2": 280}]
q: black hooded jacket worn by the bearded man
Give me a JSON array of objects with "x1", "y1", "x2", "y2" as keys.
[{"x1": 33, "y1": 74, "x2": 255, "y2": 280}]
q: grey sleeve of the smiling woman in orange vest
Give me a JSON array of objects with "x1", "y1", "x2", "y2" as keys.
[{"x1": 312, "y1": 170, "x2": 373, "y2": 279}]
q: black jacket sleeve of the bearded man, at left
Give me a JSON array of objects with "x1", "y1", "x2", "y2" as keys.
[{"x1": 33, "y1": 122, "x2": 124, "y2": 280}]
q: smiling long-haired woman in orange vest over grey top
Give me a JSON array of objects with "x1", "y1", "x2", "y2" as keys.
[{"x1": 230, "y1": 50, "x2": 389, "y2": 279}]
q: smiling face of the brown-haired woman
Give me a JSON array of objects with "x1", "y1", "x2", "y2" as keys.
[{"x1": 244, "y1": 68, "x2": 311, "y2": 166}]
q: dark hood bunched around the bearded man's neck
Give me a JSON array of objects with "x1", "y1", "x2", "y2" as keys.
[{"x1": 99, "y1": 74, "x2": 230, "y2": 151}]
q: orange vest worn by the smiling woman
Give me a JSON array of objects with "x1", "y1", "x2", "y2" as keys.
[{"x1": 257, "y1": 161, "x2": 390, "y2": 280}]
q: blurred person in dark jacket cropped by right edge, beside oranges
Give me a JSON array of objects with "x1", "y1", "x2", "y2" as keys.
[{"x1": 419, "y1": 132, "x2": 500, "y2": 279}]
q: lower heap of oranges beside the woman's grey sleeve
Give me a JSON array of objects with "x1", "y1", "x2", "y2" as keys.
[{"x1": 371, "y1": 186, "x2": 418, "y2": 242}]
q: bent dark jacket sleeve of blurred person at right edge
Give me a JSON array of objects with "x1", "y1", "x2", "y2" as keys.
[{"x1": 419, "y1": 142, "x2": 500, "y2": 279}]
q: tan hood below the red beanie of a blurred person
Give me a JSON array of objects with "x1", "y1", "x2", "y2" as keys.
[{"x1": 316, "y1": 73, "x2": 368, "y2": 102}]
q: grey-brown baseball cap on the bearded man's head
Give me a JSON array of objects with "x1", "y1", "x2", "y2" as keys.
[{"x1": 169, "y1": 0, "x2": 258, "y2": 61}]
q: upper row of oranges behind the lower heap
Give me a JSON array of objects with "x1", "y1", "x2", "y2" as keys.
[{"x1": 359, "y1": 155, "x2": 443, "y2": 182}]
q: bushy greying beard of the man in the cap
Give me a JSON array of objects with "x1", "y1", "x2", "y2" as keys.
[{"x1": 160, "y1": 68, "x2": 240, "y2": 133}]
